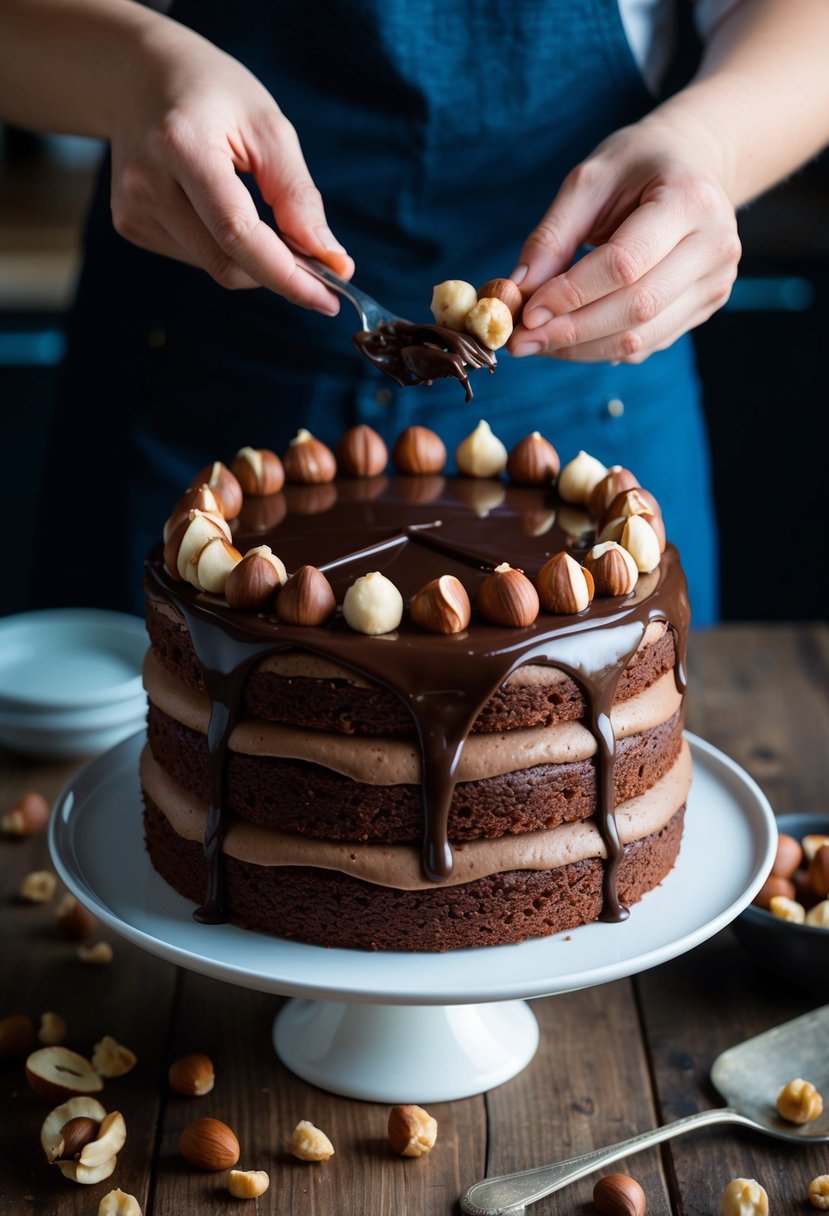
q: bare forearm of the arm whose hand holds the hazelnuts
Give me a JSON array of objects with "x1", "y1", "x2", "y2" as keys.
[{"x1": 644, "y1": 0, "x2": 829, "y2": 207}]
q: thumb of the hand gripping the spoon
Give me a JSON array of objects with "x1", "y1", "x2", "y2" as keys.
[{"x1": 256, "y1": 120, "x2": 354, "y2": 278}]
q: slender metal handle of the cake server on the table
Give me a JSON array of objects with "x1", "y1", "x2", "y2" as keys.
[{"x1": 461, "y1": 1107, "x2": 753, "y2": 1216}]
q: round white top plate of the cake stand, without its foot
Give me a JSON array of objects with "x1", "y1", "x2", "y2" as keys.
[{"x1": 50, "y1": 732, "x2": 777, "y2": 1006}]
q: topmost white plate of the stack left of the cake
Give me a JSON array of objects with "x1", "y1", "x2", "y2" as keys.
[{"x1": 0, "y1": 608, "x2": 150, "y2": 714}]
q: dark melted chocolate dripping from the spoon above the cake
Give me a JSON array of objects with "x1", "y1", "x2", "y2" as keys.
[{"x1": 354, "y1": 321, "x2": 497, "y2": 401}]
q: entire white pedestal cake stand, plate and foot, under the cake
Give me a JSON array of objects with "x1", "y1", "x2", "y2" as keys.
[{"x1": 50, "y1": 732, "x2": 777, "y2": 1103}]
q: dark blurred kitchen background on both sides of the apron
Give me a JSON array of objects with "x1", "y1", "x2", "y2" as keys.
[{"x1": 0, "y1": 126, "x2": 829, "y2": 620}]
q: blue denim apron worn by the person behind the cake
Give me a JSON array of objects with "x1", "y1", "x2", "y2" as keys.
[{"x1": 45, "y1": 0, "x2": 717, "y2": 626}]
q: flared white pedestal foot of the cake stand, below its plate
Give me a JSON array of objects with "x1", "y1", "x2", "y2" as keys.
[{"x1": 273, "y1": 997, "x2": 538, "y2": 1105}]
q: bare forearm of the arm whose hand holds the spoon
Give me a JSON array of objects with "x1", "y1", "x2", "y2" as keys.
[{"x1": 0, "y1": 0, "x2": 198, "y2": 139}]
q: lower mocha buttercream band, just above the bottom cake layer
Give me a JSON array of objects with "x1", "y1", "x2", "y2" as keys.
[{"x1": 141, "y1": 743, "x2": 692, "y2": 890}]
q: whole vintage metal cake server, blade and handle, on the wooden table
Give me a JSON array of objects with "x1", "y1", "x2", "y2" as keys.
[{"x1": 461, "y1": 1004, "x2": 829, "y2": 1216}]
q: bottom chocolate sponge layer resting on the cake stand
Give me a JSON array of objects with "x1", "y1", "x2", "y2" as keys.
[{"x1": 145, "y1": 799, "x2": 684, "y2": 952}]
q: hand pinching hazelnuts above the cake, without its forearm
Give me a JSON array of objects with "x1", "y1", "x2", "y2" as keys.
[{"x1": 508, "y1": 119, "x2": 741, "y2": 364}]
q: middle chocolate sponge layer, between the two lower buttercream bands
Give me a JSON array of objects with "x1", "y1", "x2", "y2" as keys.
[{"x1": 148, "y1": 704, "x2": 682, "y2": 843}]
